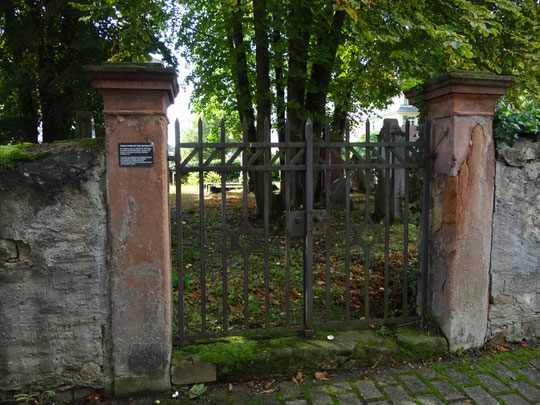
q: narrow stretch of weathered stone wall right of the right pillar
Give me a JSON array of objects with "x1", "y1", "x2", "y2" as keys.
[{"x1": 488, "y1": 138, "x2": 540, "y2": 341}]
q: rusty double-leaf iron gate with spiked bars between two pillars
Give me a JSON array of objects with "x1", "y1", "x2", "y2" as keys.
[{"x1": 169, "y1": 116, "x2": 429, "y2": 345}]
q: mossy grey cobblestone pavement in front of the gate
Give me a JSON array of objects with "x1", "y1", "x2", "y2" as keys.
[{"x1": 182, "y1": 346, "x2": 540, "y2": 405}]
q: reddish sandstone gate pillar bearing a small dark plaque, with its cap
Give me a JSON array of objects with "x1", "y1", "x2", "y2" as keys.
[{"x1": 86, "y1": 64, "x2": 178, "y2": 396}]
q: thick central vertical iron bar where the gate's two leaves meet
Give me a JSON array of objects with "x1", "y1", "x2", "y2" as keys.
[{"x1": 304, "y1": 119, "x2": 314, "y2": 337}]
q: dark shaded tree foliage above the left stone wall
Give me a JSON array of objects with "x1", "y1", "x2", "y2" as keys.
[{"x1": 0, "y1": 0, "x2": 174, "y2": 143}]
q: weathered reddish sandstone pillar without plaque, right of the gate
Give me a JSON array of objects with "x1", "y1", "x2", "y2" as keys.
[{"x1": 405, "y1": 71, "x2": 514, "y2": 350}]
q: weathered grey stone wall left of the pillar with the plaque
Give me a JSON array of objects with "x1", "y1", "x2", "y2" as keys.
[{"x1": 0, "y1": 141, "x2": 110, "y2": 398}]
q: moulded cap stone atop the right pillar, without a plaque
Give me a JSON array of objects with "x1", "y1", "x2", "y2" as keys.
[{"x1": 404, "y1": 70, "x2": 515, "y2": 105}]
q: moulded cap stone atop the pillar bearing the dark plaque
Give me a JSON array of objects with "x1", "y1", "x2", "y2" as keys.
[{"x1": 84, "y1": 63, "x2": 178, "y2": 104}]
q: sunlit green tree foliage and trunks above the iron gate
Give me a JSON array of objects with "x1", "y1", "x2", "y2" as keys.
[{"x1": 175, "y1": 0, "x2": 540, "y2": 139}]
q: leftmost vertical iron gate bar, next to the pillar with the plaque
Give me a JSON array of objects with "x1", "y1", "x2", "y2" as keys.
[{"x1": 178, "y1": 119, "x2": 185, "y2": 347}]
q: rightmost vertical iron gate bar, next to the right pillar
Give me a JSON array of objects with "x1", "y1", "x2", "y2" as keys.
[{"x1": 421, "y1": 120, "x2": 431, "y2": 322}]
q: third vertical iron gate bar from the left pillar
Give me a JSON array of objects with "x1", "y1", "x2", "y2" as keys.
[{"x1": 220, "y1": 120, "x2": 229, "y2": 333}]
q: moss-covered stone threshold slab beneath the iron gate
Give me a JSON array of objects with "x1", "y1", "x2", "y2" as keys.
[{"x1": 173, "y1": 329, "x2": 448, "y2": 384}]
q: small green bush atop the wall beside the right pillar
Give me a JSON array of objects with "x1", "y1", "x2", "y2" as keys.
[{"x1": 493, "y1": 100, "x2": 540, "y2": 146}]
